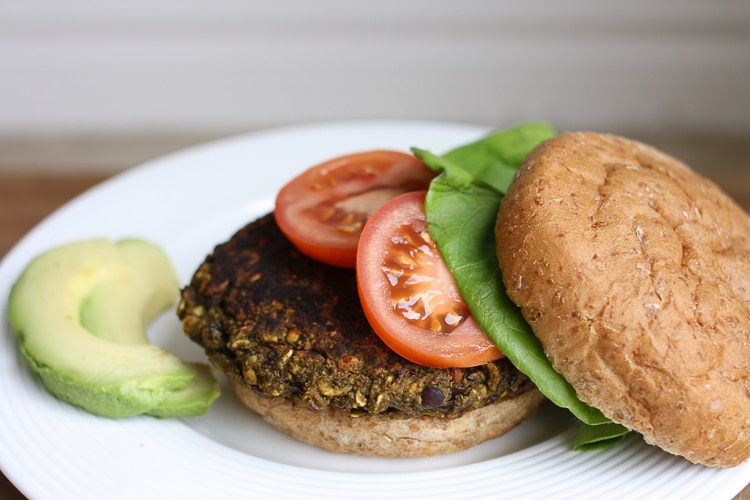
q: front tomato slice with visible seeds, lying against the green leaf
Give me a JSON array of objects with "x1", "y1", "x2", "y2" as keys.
[{"x1": 357, "y1": 191, "x2": 503, "y2": 368}]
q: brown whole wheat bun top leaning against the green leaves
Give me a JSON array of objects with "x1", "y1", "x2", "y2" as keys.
[{"x1": 495, "y1": 133, "x2": 750, "y2": 467}]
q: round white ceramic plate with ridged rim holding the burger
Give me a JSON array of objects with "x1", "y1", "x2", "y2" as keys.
[{"x1": 0, "y1": 122, "x2": 750, "y2": 499}]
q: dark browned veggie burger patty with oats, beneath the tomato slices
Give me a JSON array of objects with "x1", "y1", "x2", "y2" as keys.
[{"x1": 177, "y1": 214, "x2": 534, "y2": 417}]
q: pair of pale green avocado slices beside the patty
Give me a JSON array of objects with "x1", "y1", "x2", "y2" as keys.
[{"x1": 8, "y1": 239, "x2": 219, "y2": 418}]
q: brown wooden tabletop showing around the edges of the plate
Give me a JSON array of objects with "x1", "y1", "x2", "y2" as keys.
[{"x1": 0, "y1": 172, "x2": 750, "y2": 500}]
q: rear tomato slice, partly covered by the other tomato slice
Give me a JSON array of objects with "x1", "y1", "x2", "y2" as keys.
[{"x1": 274, "y1": 150, "x2": 435, "y2": 268}]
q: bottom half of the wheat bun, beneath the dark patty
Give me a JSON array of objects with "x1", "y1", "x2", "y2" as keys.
[{"x1": 232, "y1": 381, "x2": 544, "y2": 458}]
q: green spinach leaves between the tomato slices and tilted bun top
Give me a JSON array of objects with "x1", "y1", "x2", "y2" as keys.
[{"x1": 412, "y1": 124, "x2": 627, "y2": 449}]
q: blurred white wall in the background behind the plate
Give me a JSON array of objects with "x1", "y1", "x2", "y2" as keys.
[{"x1": 0, "y1": 0, "x2": 750, "y2": 137}]
